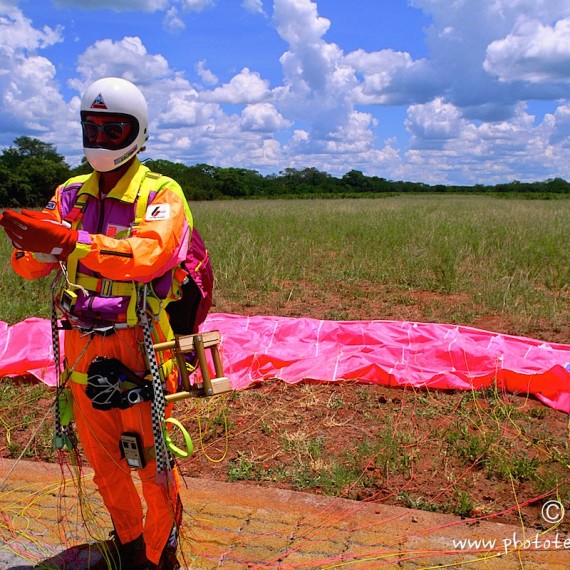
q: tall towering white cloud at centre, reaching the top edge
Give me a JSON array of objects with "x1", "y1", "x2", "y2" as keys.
[{"x1": 266, "y1": 0, "x2": 404, "y2": 175}]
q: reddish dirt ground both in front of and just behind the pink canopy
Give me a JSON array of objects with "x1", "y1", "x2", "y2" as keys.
[{"x1": 0, "y1": 283, "x2": 570, "y2": 533}]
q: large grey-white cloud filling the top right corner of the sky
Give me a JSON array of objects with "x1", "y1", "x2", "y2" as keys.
[{"x1": 404, "y1": 0, "x2": 570, "y2": 112}]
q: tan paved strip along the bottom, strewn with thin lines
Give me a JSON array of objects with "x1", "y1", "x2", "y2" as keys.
[{"x1": 0, "y1": 459, "x2": 570, "y2": 570}]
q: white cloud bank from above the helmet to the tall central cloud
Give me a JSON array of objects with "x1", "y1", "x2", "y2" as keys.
[{"x1": 58, "y1": 32, "x2": 289, "y2": 168}]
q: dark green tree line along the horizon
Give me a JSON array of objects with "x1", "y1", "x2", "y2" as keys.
[{"x1": 0, "y1": 136, "x2": 570, "y2": 208}]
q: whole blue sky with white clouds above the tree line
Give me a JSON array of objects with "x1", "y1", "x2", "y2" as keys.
[{"x1": 0, "y1": 0, "x2": 570, "y2": 185}]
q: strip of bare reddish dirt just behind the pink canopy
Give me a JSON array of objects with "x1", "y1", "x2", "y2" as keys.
[{"x1": 216, "y1": 281, "x2": 570, "y2": 344}]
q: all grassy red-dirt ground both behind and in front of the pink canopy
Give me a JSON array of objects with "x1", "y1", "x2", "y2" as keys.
[{"x1": 0, "y1": 195, "x2": 570, "y2": 526}]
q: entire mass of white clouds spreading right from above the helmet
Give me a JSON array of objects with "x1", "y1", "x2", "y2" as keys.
[{"x1": 62, "y1": 0, "x2": 570, "y2": 183}]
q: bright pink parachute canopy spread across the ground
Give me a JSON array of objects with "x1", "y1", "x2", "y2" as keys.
[{"x1": 0, "y1": 313, "x2": 570, "y2": 413}]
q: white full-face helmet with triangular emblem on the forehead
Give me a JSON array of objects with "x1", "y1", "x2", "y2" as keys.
[{"x1": 81, "y1": 77, "x2": 148, "y2": 172}]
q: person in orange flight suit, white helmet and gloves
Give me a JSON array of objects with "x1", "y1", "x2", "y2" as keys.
[{"x1": 0, "y1": 77, "x2": 209, "y2": 570}]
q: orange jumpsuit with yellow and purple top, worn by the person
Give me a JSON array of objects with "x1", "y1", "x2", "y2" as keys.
[{"x1": 12, "y1": 159, "x2": 192, "y2": 564}]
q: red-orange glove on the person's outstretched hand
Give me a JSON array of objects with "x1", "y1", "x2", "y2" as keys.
[{"x1": 0, "y1": 210, "x2": 78, "y2": 259}]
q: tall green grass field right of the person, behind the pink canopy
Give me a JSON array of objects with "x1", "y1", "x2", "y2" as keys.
[{"x1": 193, "y1": 196, "x2": 570, "y2": 340}]
